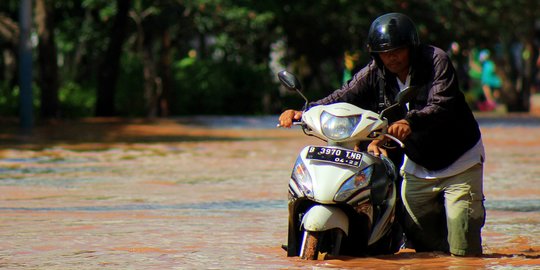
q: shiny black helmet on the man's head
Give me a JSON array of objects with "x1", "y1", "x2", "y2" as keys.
[{"x1": 367, "y1": 13, "x2": 420, "y2": 53}]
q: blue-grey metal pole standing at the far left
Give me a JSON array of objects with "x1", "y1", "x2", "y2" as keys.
[{"x1": 19, "y1": 0, "x2": 34, "y2": 134}]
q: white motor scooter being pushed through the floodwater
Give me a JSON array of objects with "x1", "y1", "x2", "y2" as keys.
[{"x1": 278, "y1": 71, "x2": 411, "y2": 260}]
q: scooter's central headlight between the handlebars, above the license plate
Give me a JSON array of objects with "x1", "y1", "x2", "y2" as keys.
[{"x1": 321, "y1": 112, "x2": 361, "y2": 141}]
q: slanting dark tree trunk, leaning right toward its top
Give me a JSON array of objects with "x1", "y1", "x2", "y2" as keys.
[{"x1": 96, "y1": 0, "x2": 131, "y2": 116}]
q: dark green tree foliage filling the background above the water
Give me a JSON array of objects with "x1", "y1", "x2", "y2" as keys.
[{"x1": 0, "y1": 0, "x2": 540, "y2": 117}]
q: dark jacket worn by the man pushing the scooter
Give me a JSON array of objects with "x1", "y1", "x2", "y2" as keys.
[{"x1": 310, "y1": 45, "x2": 481, "y2": 170}]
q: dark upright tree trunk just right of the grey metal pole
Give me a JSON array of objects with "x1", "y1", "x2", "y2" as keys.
[{"x1": 35, "y1": 0, "x2": 60, "y2": 118}]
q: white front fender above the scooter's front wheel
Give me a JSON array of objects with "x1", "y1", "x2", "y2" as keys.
[{"x1": 302, "y1": 205, "x2": 349, "y2": 235}]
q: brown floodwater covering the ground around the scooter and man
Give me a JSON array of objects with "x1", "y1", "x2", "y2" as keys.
[{"x1": 0, "y1": 116, "x2": 540, "y2": 269}]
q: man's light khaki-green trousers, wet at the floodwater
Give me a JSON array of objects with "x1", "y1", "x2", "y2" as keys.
[{"x1": 401, "y1": 164, "x2": 485, "y2": 256}]
